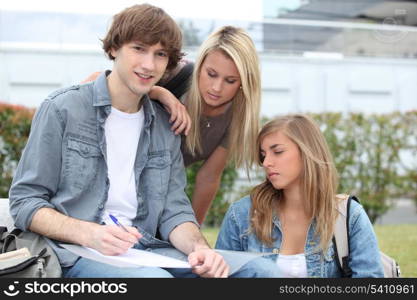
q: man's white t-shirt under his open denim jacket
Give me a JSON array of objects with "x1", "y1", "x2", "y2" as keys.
[{"x1": 103, "y1": 107, "x2": 145, "y2": 226}]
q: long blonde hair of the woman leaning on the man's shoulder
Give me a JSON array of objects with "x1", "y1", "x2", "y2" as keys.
[{"x1": 186, "y1": 26, "x2": 261, "y2": 170}]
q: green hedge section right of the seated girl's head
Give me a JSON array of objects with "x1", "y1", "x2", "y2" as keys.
[{"x1": 312, "y1": 112, "x2": 417, "y2": 222}]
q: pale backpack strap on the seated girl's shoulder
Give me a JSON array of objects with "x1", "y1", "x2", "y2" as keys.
[{"x1": 333, "y1": 195, "x2": 359, "y2": 277}]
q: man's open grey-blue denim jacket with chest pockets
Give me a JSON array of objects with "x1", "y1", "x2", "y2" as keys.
[{"x1": 9, "y1": 71, "x2": 197, "y2": 267}]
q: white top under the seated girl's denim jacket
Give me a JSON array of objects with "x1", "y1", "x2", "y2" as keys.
[{"x1": 277, "y1": 253, "x2": 307, "y2": 278}]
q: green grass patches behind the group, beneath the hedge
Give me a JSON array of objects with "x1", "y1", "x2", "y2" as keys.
[{"x1": 203, "y1": 224, "x2": 417, "y2": 278}]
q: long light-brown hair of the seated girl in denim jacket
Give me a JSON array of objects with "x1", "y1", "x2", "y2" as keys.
[{"x1": 251, "y1": 115, "x2": 338, "y2": 251}]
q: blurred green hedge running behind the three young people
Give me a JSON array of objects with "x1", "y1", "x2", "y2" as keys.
[{"x1": 0, "y1": 103, "x2": 417, "y2": 226}]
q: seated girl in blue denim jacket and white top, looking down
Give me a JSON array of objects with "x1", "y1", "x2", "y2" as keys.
[{"x1": 216, "y1": 115, "x2": 384, "y2": 277}]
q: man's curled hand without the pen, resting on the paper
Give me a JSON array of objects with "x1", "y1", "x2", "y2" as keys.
[{"x1": 188, "y1": 248, "x2": 229, "y2": 278}]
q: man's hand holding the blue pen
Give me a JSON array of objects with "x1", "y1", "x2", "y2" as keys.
[{"x1": 86, "y1": 224, "x2": 142, "y2": 255}]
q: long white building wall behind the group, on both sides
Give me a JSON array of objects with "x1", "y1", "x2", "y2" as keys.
[{"x1": 0, "y1": 44, "x2": 417, "y2": 117}]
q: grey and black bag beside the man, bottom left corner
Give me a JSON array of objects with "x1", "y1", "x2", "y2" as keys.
[{"x1": 0, "y1": 227, "x2": 62, "y2": 278}]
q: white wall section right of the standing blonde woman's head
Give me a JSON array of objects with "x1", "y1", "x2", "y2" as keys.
[{"x1": 261, "y1": 54, "x2": 417, "y2": 117}]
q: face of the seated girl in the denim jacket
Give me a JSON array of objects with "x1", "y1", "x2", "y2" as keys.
[{"x1": 261, "y1": 131, "x2": 303, "y2": 189}]
